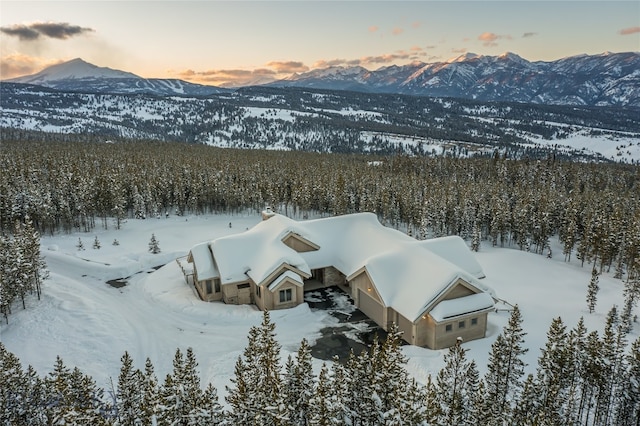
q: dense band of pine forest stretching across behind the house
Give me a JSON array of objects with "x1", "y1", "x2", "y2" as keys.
[{"x1": 0, "y1": 136, "x2": 640, "y2": 277}]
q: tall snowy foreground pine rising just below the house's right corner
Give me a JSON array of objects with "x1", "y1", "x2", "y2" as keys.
[{"x1": 485, "y1": 305, "x2": 528, "y2": 425}]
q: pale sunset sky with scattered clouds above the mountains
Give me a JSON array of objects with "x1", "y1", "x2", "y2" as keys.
[{"x1": 0, "y1": 0, "x2": 640, "y2": 86}]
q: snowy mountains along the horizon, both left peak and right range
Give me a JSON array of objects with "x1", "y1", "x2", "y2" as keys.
[{"x1": 5, "y1": 52, "x2": 640, "y2": 107}]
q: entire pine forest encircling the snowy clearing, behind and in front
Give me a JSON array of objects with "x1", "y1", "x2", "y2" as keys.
[{"x1": 0, "y1": 135, "x2": 640, "y2": 426}]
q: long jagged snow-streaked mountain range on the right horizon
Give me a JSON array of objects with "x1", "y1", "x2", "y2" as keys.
[{"x1": 270, "y1": 52, "x2": 640, "y2": 107}]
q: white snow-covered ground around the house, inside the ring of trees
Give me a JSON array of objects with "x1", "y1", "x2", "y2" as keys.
[{"x1": 0, "y1": 213, "x2": 640, "y2": 402}]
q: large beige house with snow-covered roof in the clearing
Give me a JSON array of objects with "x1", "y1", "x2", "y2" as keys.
[{"x1": 187, "y1": 211, "x2": 494, "y2": 349}]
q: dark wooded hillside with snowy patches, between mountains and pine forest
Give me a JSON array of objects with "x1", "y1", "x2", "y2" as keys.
[{"x1": 0, "y1": 84, "x2": 640, "y2": 162}]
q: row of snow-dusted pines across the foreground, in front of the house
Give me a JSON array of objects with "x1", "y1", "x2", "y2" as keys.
[{"x1": 0, "y1": 306, "x2": 640, "y2": 426}]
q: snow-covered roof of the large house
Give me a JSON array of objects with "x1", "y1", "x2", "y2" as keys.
[{"x1": 188, "y1": 213, "x2": 491, "y2": 321}]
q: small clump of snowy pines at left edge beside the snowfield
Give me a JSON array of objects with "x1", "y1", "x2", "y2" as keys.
[{"x1": 0, "y1": 216, "x2": 48, "y2": 323}]
